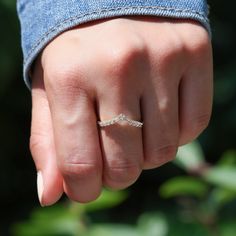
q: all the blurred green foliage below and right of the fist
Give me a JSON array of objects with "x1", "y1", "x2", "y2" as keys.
[{"x1": 12, "y1": 142, "x2": 236, "y2": 236}]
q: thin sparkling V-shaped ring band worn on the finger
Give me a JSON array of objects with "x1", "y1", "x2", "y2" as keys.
[{"x1": 98, "y1": 113, "x2": 143, "y2": 128}]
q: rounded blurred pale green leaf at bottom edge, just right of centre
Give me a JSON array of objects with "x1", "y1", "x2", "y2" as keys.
[{"x1": 138, "y1": 213, "x2": 168, "y2": 236}]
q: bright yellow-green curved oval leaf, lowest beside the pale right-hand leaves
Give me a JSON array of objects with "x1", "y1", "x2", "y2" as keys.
[{"x1": 159, "y1": 176, "x2": 208, "y2": 198}]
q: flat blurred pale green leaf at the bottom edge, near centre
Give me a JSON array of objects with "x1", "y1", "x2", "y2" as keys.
[{"x1": 87, "y1": 224, "x2": 137, "y2": 236}]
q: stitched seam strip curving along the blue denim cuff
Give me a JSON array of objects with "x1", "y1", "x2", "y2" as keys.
[{"x1": 24, "y1": 6, "x2": 208, "y2": 64}]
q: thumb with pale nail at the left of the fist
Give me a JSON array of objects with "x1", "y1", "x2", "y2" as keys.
[{"x1": 30, "y1": 63, "x2": 63, "y2": 206}]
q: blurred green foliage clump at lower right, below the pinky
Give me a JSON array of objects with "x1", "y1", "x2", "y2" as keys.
[{"x1": 160, "y1": 142, "x2": 236, "y2": 236}]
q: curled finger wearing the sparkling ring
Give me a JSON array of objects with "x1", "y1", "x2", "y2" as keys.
[{"x1": 98, "y1": 86, "x2": 143, "y2": 189}]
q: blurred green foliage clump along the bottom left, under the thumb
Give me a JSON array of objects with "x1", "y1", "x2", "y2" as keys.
[{"x1": 12, "y1": 191, "x2": 168, "y2": 236}]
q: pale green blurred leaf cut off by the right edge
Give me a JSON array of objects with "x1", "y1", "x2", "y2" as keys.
[{"x1": 203, "y1": 166, "x2": 236, "y2": 191}]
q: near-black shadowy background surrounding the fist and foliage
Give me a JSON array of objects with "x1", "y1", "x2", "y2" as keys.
[{"x1": 0, "y1": 0, "x2": 236, "y2": 236}]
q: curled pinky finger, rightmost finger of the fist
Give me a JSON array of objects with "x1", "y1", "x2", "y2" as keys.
[{"x1": 179, "y1": 43, "x2": 213, "y2": 145}]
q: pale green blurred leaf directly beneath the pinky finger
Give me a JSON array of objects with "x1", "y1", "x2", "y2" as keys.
[{"x1": 174, "y1": 141, "x2": 205, "y2": 171}]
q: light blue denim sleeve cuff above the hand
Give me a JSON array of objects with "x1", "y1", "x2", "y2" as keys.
[{"x1": 17, "y1": 0, "x2": 210, "y2": 87}]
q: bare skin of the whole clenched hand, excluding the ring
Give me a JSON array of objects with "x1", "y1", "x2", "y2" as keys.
[{"x1": 30, "y1": 16, "x2": 213, "y2": 206}]
